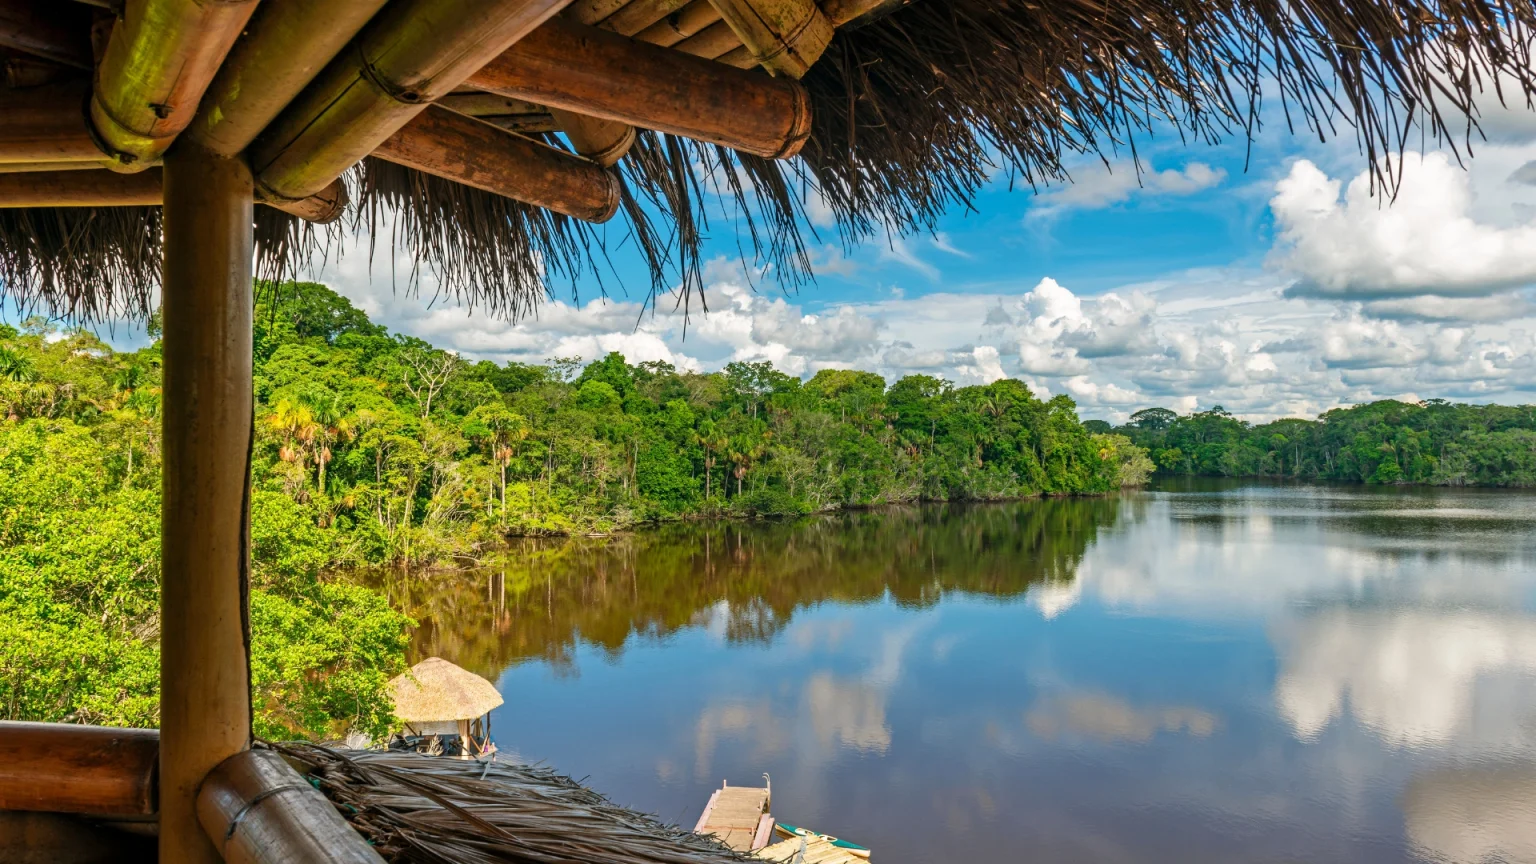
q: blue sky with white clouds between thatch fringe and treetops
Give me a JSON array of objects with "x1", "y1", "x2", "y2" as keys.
[{"x1": 29, "y1": 88, "x2": 1536, "y2": 420}]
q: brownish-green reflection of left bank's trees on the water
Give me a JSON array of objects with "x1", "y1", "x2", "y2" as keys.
[{"x1": 369, "y1": 498, "x2": 1130, "y2": 680}]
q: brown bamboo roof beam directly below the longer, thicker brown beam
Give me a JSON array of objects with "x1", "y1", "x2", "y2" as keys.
[{"x1": 373, "y1": 106, "x2": 621, "y2": 221}]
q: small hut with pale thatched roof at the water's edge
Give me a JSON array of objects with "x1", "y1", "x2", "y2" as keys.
[{"x1": 389, "y1": 656, "x2": 504, "y2": 758}]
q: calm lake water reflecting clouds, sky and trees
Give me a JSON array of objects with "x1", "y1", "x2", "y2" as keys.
[{"x1": 377, "y1": 483, "x2": 1536, "y2": 864}]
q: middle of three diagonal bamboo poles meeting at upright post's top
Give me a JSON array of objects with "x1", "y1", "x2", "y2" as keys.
[{"x1": 187, "y1": 0, "x2": 384, "y2": 157}]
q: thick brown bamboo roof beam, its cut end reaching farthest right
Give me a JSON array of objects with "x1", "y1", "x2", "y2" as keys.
[{"x1": 467, "y1": 20, "x2": 811, "y2": 158}]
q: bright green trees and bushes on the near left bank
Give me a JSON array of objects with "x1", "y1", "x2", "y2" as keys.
[{"x1": 0, "y1": 284, "x2": 1152, "y2": 736}]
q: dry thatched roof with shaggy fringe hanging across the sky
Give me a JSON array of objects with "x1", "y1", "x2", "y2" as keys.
[{"x1": 0, "y1": 0, "x2": 1536, "y2": 321}]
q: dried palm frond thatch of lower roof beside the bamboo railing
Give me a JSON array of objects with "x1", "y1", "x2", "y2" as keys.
[{"x1": 272, "y1": 744, "x2": 748, "y2": 864}]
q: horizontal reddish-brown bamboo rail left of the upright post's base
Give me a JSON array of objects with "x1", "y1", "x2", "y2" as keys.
[{"x1": 0, "y1": 721, "x2": 160, "y2": 816}]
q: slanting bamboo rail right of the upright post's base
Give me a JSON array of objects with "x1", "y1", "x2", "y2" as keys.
[{"x1": 197, "y1": 750, "x2": 384, "y2": 864}]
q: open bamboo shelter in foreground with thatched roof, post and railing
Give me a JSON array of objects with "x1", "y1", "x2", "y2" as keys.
[{"x1": 0, "y1": 0, "x2": 1536, "y2": 864}]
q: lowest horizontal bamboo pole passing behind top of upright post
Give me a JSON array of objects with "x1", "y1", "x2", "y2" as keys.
[{"x1": 0, "y1": 161, "x2": 347, "y2": 224}]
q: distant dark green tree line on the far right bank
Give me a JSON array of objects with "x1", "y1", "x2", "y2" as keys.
[{"x1": 1118, "y1": 400, "x2": 1536, "y2": 486}]
